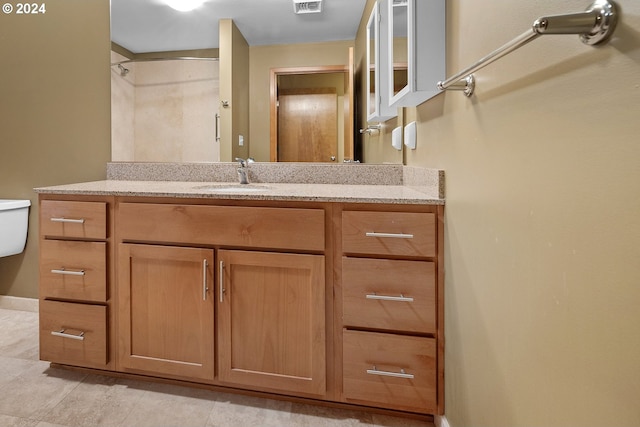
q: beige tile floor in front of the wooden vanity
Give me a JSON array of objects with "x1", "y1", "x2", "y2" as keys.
[{"x1": 0, "y1": 309, "x2": 433, "y2": 427}]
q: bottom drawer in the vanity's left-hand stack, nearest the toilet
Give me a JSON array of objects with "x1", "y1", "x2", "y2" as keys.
[{"x1": 40, "y1": 300, "x2": 108, "y2": 368}]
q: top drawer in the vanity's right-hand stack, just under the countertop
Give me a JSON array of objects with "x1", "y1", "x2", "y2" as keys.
[{"x1": 342, "y1": 211, "x2": 436, "y2": 257}]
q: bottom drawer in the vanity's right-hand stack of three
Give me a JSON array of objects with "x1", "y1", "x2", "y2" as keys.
[{"x1": 343, "y1": 331, "x2": 437, "y2": 413}]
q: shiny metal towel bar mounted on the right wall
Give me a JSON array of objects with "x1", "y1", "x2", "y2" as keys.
[{"x1": 438, "y1": 0, "x2": 618, "y2": 96}]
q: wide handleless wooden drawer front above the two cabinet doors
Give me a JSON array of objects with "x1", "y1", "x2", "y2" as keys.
[{"x1": 118, "y1": 203, "x2": 325, "y2": 251}]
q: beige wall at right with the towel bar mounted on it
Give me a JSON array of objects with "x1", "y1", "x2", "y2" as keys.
[{"x1": 364, "y1": 0, "x2": 640, "y2": 427}]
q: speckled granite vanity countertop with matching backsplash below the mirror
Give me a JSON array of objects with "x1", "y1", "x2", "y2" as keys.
[{"x1": 35, "y1": 163, "x2": 444, "y2": 205}]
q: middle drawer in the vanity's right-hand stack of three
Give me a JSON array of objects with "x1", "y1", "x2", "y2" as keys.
[{"x1": 342, "y1": 257, "x2": 436, "y2": 333}]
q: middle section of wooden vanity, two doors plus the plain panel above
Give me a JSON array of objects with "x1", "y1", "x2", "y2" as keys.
[{"x1": 116, "y1": 201, "x2": 327, "y2": 397}]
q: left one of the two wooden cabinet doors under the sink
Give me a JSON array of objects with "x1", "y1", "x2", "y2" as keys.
[{"x1": 118, "y1": 244, "x2": 214, "y2": 380}]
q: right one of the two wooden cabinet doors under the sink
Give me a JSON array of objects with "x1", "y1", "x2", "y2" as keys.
[{"x1": 218, "y1": 250, "x2": 326, "y2": 396}]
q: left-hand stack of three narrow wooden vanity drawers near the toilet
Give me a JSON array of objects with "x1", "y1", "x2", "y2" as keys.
[{"x1": 39, "y1": 195, "x2": 113, "y2": 369}]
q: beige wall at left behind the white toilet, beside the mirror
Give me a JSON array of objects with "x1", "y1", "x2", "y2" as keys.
[{"x1": 0, "y1": 0, "x2": 110, "y2": 297}]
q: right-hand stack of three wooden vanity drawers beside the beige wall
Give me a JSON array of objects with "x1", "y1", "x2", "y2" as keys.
[{"x1": 336, "y1": 205, "x2": 444, "y2": 414}]
